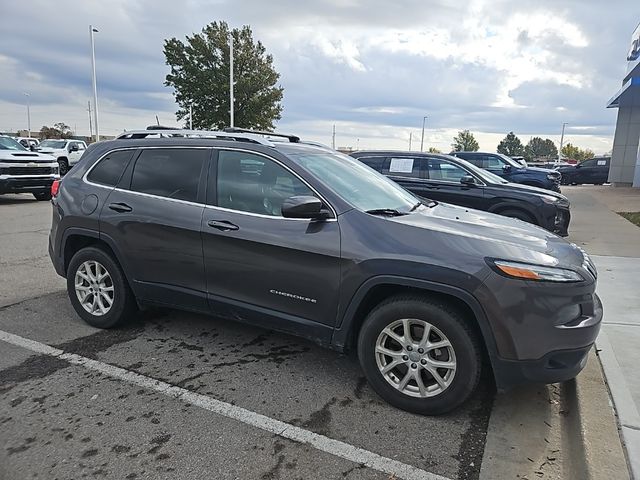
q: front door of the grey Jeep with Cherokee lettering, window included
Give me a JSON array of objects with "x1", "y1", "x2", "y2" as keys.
[{"x1": 202, "y1": 150, "x2": 340, "y2": 332}]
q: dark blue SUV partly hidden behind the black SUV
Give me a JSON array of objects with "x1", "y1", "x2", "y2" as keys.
[{"x1": 451, "y1": 152, "x2": 562, "y2": 192}]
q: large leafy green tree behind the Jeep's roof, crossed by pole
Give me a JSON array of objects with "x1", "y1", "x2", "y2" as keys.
[{"x1": 164, "y1": 22, "x2": 283, "y2": 130}]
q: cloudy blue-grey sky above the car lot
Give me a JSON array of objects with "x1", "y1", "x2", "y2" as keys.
[{"x1": 0, "y1": 0, "x2": 640, "y2": 153}]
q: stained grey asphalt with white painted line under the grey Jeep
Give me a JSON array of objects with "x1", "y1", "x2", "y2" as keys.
[{"x1": 0, "y1": 195, "x2": 493, "y2": 480}]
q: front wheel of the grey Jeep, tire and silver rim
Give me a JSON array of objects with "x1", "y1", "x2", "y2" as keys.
[{"x1": 358, "y1": 296, "x2": 481, "y2": 415}]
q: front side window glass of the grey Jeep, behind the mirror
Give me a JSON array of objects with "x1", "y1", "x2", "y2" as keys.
[{"x1": 216, "y1": 150, "x2": 314, "y2": 217}]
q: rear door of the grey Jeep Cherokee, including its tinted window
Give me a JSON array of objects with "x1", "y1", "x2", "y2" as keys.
[{"x1": 100, "y1": 147, "x2": 211, "y2": 310}]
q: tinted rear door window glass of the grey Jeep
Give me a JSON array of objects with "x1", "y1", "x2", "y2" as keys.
[{"x1": 131, "y1": 148, "x2": 210, "y2": 202}]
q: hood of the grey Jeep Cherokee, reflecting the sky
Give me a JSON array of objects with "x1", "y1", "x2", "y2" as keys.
[{"x1": 390, "y1": 203, "x2": 583, "y2": 267}]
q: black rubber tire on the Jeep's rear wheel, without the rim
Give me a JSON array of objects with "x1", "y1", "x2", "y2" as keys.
[{"x1": 67, "y1": 247, "x2": 137, "y2": 328}]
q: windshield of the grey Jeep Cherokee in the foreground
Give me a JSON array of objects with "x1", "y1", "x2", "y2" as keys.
[{"x1": 289, "y1": 152, "x2": 419, "y2": 213}]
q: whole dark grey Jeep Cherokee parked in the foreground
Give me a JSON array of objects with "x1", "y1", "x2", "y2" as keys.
[{"x1": 49, "y1": 130, "x2": 602, "y2": 414}]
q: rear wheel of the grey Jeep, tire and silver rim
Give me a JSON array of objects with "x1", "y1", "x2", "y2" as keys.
[{"x1": 67, "y1": 247, "x2": 136, "y2": 328}]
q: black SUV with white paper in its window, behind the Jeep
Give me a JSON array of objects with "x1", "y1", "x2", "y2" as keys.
[{"x1": 350, "y1": 151, "x2": 571, "y2": 237}]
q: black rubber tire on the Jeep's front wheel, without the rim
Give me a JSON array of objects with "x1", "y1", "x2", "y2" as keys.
[{"x1": 358, "y1": 295, "x2": 482, "y2": 415}]
